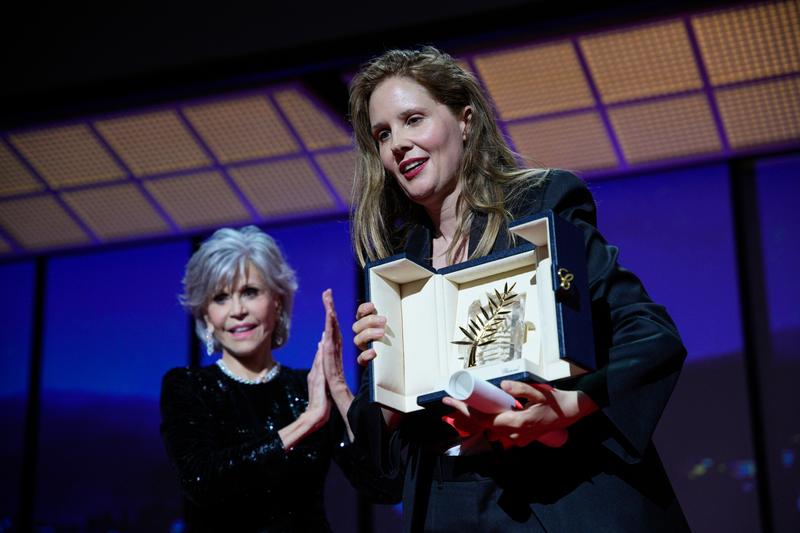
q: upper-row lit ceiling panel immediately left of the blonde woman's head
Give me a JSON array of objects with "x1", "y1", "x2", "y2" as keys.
[{"x1": 275, "y1": 89, "x2": 350, "y2": 150}]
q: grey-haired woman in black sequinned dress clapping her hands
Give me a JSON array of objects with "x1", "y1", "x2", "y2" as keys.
[{"x1": 161, "y1": 226, "x2": 360, "y2": 531}]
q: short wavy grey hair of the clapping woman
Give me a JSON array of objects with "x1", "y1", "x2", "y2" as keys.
[{"x1": 178, "y1": 226, "x2": 297, "y2": 350}]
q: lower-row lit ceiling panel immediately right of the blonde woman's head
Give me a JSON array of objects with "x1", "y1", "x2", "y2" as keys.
[{"x1": 508, "y1": 112, "x2": 618, "y2": 170}]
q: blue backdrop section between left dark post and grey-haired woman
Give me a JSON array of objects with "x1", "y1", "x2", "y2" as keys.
[{"x1": 35, "y1": 242, "x2": 190, "y2": 531}]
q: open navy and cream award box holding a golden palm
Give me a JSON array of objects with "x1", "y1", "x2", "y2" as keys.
[{"x1": 366, "y1": 211, "x2": 596, "y2": 413}]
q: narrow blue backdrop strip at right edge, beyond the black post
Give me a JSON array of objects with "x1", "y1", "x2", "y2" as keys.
[{"x1": 754, "y1": 155, "x2": 800, "y2": 531}]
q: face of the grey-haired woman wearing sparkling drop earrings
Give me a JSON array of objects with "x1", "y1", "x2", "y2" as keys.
[{"x1": 205, "y1": 264, "x2": 281, "y2": 358}]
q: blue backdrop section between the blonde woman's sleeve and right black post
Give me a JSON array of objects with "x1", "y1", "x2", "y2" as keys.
[{"x1": 592, "y1": 164, "x2": 759, "y2": 531}]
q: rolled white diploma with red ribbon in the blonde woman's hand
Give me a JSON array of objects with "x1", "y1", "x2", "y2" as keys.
[{"x1": 445, "y1": 370, "x2": 567, "y2": 448}]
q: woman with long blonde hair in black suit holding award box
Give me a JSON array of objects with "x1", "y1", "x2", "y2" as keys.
[{"x1": 348, "y1": 47, "x2": 688, "y2": 531}]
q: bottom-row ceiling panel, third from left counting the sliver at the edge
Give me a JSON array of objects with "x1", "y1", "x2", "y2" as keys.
[{"x1": 63, "y1": 184, "x2": 169, "y2": 239}]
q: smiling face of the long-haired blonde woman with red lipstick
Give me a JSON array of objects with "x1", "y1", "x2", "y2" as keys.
[{"x1": 369, "y1": 77, "x2": 472, "y2": 209}]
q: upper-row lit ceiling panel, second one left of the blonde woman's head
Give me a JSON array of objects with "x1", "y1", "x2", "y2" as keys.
[{"x1": 184, "y1": 96, "x2": 299, "y2": 163}]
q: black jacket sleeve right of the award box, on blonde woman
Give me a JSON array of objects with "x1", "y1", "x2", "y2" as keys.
[{"x1": 540, "y1": 171, "x2": 686, "y2": 462}]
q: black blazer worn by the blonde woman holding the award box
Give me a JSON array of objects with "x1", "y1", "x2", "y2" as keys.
[{"x1": 348, "y1": 170, "x2": 688, "y2": 532}]
